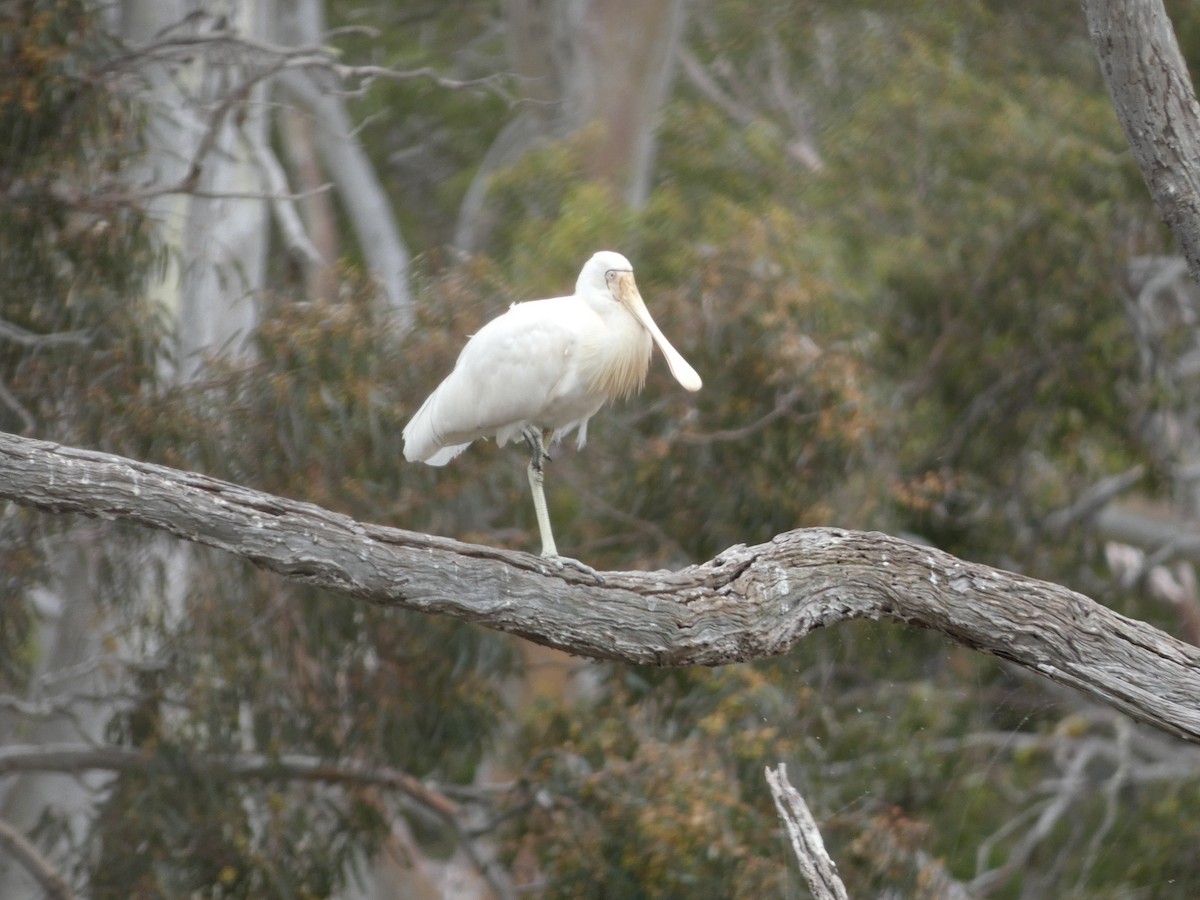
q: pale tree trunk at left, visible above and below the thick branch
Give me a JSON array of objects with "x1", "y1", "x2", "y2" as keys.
[{"x1": 0, "y1": 0, "x2": 275, "y2": 898}]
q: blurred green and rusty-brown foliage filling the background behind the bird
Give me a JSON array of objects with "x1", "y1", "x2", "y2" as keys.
[{"x1": 0, "y1": 0, "x2": 1200, "y2": 898}]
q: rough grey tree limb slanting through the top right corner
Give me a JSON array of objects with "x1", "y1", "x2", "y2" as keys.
[{"x1": 1082, "y1": 0, "x2": 1200, "y2": 282}]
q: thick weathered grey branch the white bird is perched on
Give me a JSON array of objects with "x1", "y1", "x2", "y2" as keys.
[{"x1": 0, "y1": 434, "x2": 1200, "y2": 743}]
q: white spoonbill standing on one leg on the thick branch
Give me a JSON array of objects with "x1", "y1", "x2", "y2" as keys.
[{"x1": 404, "y1": 251, "x2": 701, "y2": 557}]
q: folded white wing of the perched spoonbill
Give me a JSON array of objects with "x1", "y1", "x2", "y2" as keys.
[{"x1": 404, "y1": 298, "x2": 599, "y2": 464}]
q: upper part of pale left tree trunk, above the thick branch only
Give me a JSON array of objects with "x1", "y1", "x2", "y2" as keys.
[{"x1": 120, "y1": 0, "x2": 275, "y2": 379}]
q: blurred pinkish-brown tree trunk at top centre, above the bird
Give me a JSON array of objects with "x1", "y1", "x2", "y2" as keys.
[{"x1": 455, "y1": 0, "x2": 684, "y2": 252}]
